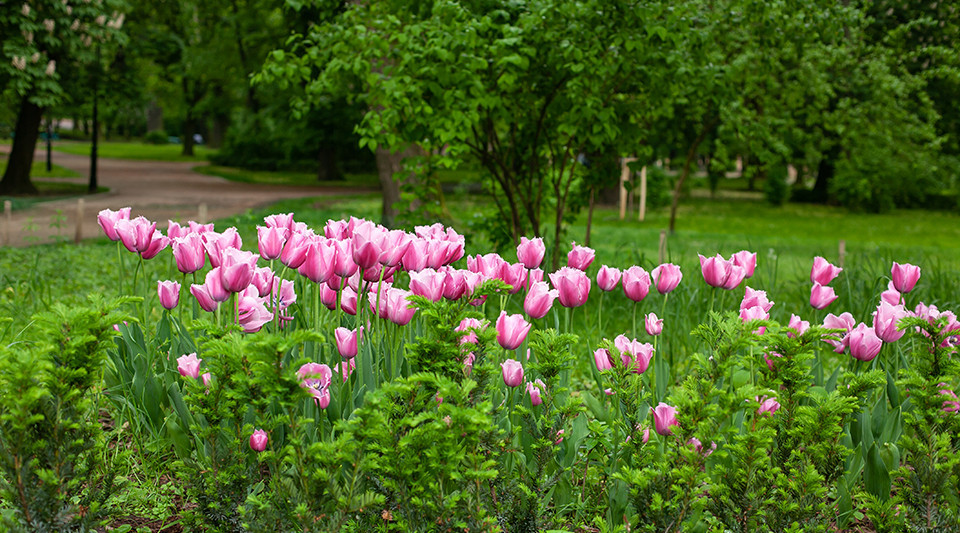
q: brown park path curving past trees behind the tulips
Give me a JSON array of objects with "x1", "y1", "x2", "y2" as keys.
[{"x1": 0, "y1": 145, "x2": 369, "y2": 246}]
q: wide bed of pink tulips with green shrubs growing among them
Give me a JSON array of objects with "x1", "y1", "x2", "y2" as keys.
[{"x1": 90, "y1": 208, "x2": 960, "y2": 531}]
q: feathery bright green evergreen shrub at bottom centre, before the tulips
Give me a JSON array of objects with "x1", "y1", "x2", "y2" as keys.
[{"x1": 348, "y1": 374, "x2": 498, "y2": 531}]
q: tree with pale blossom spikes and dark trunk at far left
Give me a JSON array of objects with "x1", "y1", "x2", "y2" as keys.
[{"x1": 0, "y1": 0, "x2": 125, "y2": 194}]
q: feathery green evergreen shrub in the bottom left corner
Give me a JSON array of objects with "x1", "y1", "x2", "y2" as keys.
[{"x1": 0, "y1": 297, "x2": 131, "y2": 532}]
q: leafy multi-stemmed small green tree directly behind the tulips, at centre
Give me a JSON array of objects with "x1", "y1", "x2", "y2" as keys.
[{"x1": 260, "y1": 0, "x2": 686, "y2": 263}]
